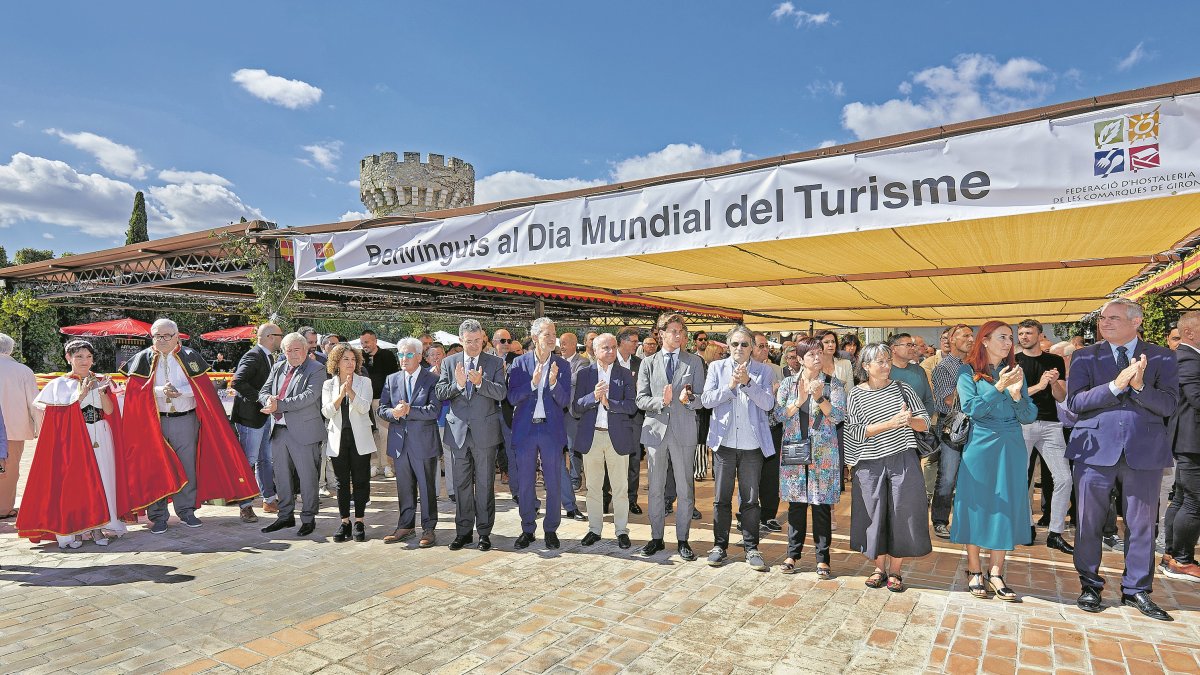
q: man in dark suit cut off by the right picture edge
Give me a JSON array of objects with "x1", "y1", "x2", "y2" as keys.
[{"x1": 1159, "y1": 311, "x2": 1200, "y2": 581}]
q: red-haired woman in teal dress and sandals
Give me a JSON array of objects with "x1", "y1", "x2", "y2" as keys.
[{"x1": 950, "y1": 321, "x2": 1038, "y2": 602}]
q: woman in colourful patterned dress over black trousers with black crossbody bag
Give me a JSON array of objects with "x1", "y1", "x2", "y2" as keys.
[{"x1": 775, "y1": 338, "x2": 846, "y2": 571}]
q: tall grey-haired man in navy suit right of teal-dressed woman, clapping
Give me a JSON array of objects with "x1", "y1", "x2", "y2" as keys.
[{"x1": 1067, "y1": 298, "x2": 1178, "y2": 621}]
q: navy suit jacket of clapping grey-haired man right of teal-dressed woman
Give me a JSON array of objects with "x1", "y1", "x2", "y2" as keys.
[{"x1": 1067, "y1": 340, "x2": 1180, "y2": 470}]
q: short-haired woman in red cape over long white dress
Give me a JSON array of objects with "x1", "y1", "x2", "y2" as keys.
[{"x1": 17, "y1": 340, "x2": 184, "y2": 549}]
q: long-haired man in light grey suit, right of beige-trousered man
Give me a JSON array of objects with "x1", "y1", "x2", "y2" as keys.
[{"x1": 637, "y1": 313, "x2": 704, "y2": 561}]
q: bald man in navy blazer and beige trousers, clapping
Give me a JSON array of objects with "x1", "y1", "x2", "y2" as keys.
[{"x1": 571, "y1": 333, "x2": 638, "y2": 549}]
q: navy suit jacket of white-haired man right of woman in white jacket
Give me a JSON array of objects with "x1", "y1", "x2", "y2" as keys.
[{"x1": 377, "y1": 368, "x2": 442, "y2": 459}]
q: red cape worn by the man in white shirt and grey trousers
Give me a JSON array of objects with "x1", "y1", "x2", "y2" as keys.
[{"x1": 122, "y1": 354, "x2": 259, "y2": 504}]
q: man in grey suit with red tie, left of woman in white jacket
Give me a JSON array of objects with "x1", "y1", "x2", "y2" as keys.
[{"x1": 258, "y1": 333, "x2": 326, "y2": 537}]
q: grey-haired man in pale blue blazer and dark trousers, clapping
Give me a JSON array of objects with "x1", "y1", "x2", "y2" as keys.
[{"x1": 701, "y1": 325, "x2": 775, "y2": 572}]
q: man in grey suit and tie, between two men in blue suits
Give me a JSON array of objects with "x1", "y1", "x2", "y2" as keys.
[{"x1": 434, "y1": 318, "x2": 515, "y2": 551}]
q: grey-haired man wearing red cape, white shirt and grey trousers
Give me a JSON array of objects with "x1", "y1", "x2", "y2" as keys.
[{"x1": 122, "y1": 318, "x2": 259, "y2": 534}]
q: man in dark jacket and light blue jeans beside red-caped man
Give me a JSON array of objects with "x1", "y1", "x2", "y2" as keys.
[{"x1": 230, "y1": 323, "x2": 283, "y2": 522}]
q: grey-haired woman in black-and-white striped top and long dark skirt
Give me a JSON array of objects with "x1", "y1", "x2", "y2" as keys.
[{"x1": 846, "y1": 342, "x2": 934, "y2": 593}]
